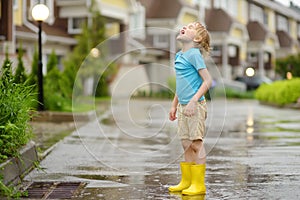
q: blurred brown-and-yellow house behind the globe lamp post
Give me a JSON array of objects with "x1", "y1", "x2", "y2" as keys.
[{"x1": 0, "y1": 0, "x2": 142, "y2": 73}]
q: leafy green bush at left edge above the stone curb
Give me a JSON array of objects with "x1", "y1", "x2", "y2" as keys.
[{"x1": 0, "y1": 72, "x2": 33, "y2": 162}]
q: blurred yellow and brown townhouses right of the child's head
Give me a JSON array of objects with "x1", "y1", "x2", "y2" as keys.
[{"x1": 205, "y1": 0, "x2": 300, "y2": 79}]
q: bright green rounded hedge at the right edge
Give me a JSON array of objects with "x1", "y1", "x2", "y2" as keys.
[{"x1": 255, "y1": 78, "x2": 300, "y2": 106}]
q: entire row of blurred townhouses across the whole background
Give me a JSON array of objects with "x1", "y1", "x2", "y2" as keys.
[{"x1": 0, "y1": 0, "x2": 300, "y2": 95}]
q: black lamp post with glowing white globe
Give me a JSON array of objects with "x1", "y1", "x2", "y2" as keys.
[{"x1": 31, "y1": 4, "x2": 49, "y2": 111}]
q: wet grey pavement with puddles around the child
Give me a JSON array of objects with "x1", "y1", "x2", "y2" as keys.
[{"x1": 25, "y1": 99, "x2": 300, "y2": 200}]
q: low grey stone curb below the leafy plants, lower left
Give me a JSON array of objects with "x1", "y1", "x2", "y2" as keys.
[{"x1": 0, "y1": 141, "x2": 38, "y2": 185}]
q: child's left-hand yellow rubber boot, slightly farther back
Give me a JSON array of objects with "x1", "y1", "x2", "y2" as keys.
[{"x1": 169, "y1": 162, "x2": 192, "y2": 192}]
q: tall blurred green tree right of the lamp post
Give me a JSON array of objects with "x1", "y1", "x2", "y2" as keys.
[{"x1": 63, "y1": 1, "x2": 116, "y2": 96}]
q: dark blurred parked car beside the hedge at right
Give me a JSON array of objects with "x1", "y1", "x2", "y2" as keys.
[{"x1": 235, "y1": 75, "x2": 273, "y2": 90}]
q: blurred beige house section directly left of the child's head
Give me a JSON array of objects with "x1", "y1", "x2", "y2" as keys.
[{"x1": 132, "y1": 0, "x2": 199, "y2": 92}]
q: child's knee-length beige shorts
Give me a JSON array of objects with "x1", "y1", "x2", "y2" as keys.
[{"x1": 177, "y1": 101, "x2": 207, "y2": 140}]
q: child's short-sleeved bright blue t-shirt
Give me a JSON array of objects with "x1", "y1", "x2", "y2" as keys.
[{"x1": 175, "y1": 48, "x2": 206, "y2": 104}]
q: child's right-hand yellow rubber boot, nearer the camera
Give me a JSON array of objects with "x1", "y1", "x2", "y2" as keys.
[{"x1": 182, "y1": 164, "x2": 206, "y2": 195}]
